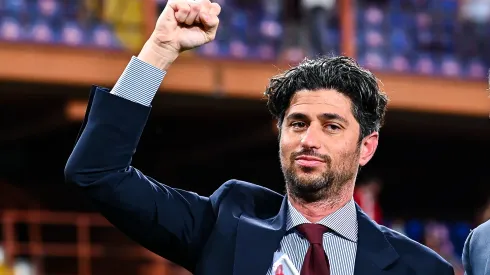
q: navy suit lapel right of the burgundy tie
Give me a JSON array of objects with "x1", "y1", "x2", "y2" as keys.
[{"x1": 354, "y1": 204, "x2": 409, "y2": 275}]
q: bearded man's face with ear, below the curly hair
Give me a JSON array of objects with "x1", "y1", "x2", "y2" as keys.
[{"x1": 279, "y1": 90, "x2": 378, "y2": 202}]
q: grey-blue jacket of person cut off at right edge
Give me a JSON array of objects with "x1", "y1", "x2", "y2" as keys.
[{"x1": 463, "y1": 220, "x2": 490, "y2": 275}]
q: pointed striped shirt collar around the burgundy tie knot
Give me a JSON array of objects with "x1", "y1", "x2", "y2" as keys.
[{"x1": 286, "y1": 199, "x2": 358, "y2": 242}]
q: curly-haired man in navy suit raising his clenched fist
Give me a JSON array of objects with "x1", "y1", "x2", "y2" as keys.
[{"x1": 65, "y1": 0, "x2": 454, "y2": 275}]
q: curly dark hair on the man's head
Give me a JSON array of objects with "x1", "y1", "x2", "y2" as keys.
[{"x1": 265, "y1": 56, "x2": 388, "y2": 140}]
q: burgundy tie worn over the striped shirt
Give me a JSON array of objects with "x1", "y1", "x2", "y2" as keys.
[{"x1": 297, "y1": 224, "x2": 330, "y2": 275}]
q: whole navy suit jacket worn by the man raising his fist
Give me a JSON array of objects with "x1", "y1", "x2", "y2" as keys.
[{"x1": 65, "y1": 87, "x2": 454, "y2": 275}]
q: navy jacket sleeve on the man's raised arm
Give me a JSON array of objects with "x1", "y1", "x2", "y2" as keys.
[{"x1": 65, "y1": 87, "x2": 230, "y2": 272}]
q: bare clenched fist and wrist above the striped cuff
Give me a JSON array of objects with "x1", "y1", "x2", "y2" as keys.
[{"x1": 138, "y1": 0, "x2": 221, "y2": 69}]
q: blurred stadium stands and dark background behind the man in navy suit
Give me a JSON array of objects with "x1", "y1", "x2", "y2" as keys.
[{"x1": 0, "y1": 0, "x2": 490, "y2": 275}]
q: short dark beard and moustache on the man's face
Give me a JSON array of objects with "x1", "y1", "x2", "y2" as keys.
[{"x1": 282, "y1": 147, "x2": 360, "y2": 203}]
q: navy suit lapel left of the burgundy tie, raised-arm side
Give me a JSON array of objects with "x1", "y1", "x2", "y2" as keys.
[{"x1": 233, "y1": 197, "x2": 287, "y2": 275}]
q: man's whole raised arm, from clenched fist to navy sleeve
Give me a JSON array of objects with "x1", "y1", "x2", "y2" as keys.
[{"x1": 65, "y1": 0, "x2": 222, "y2": 271}]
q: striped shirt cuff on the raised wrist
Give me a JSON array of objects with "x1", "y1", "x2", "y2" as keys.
[{"x1": 111, "y1": 56, "x2": 167, "y2": 106}]
